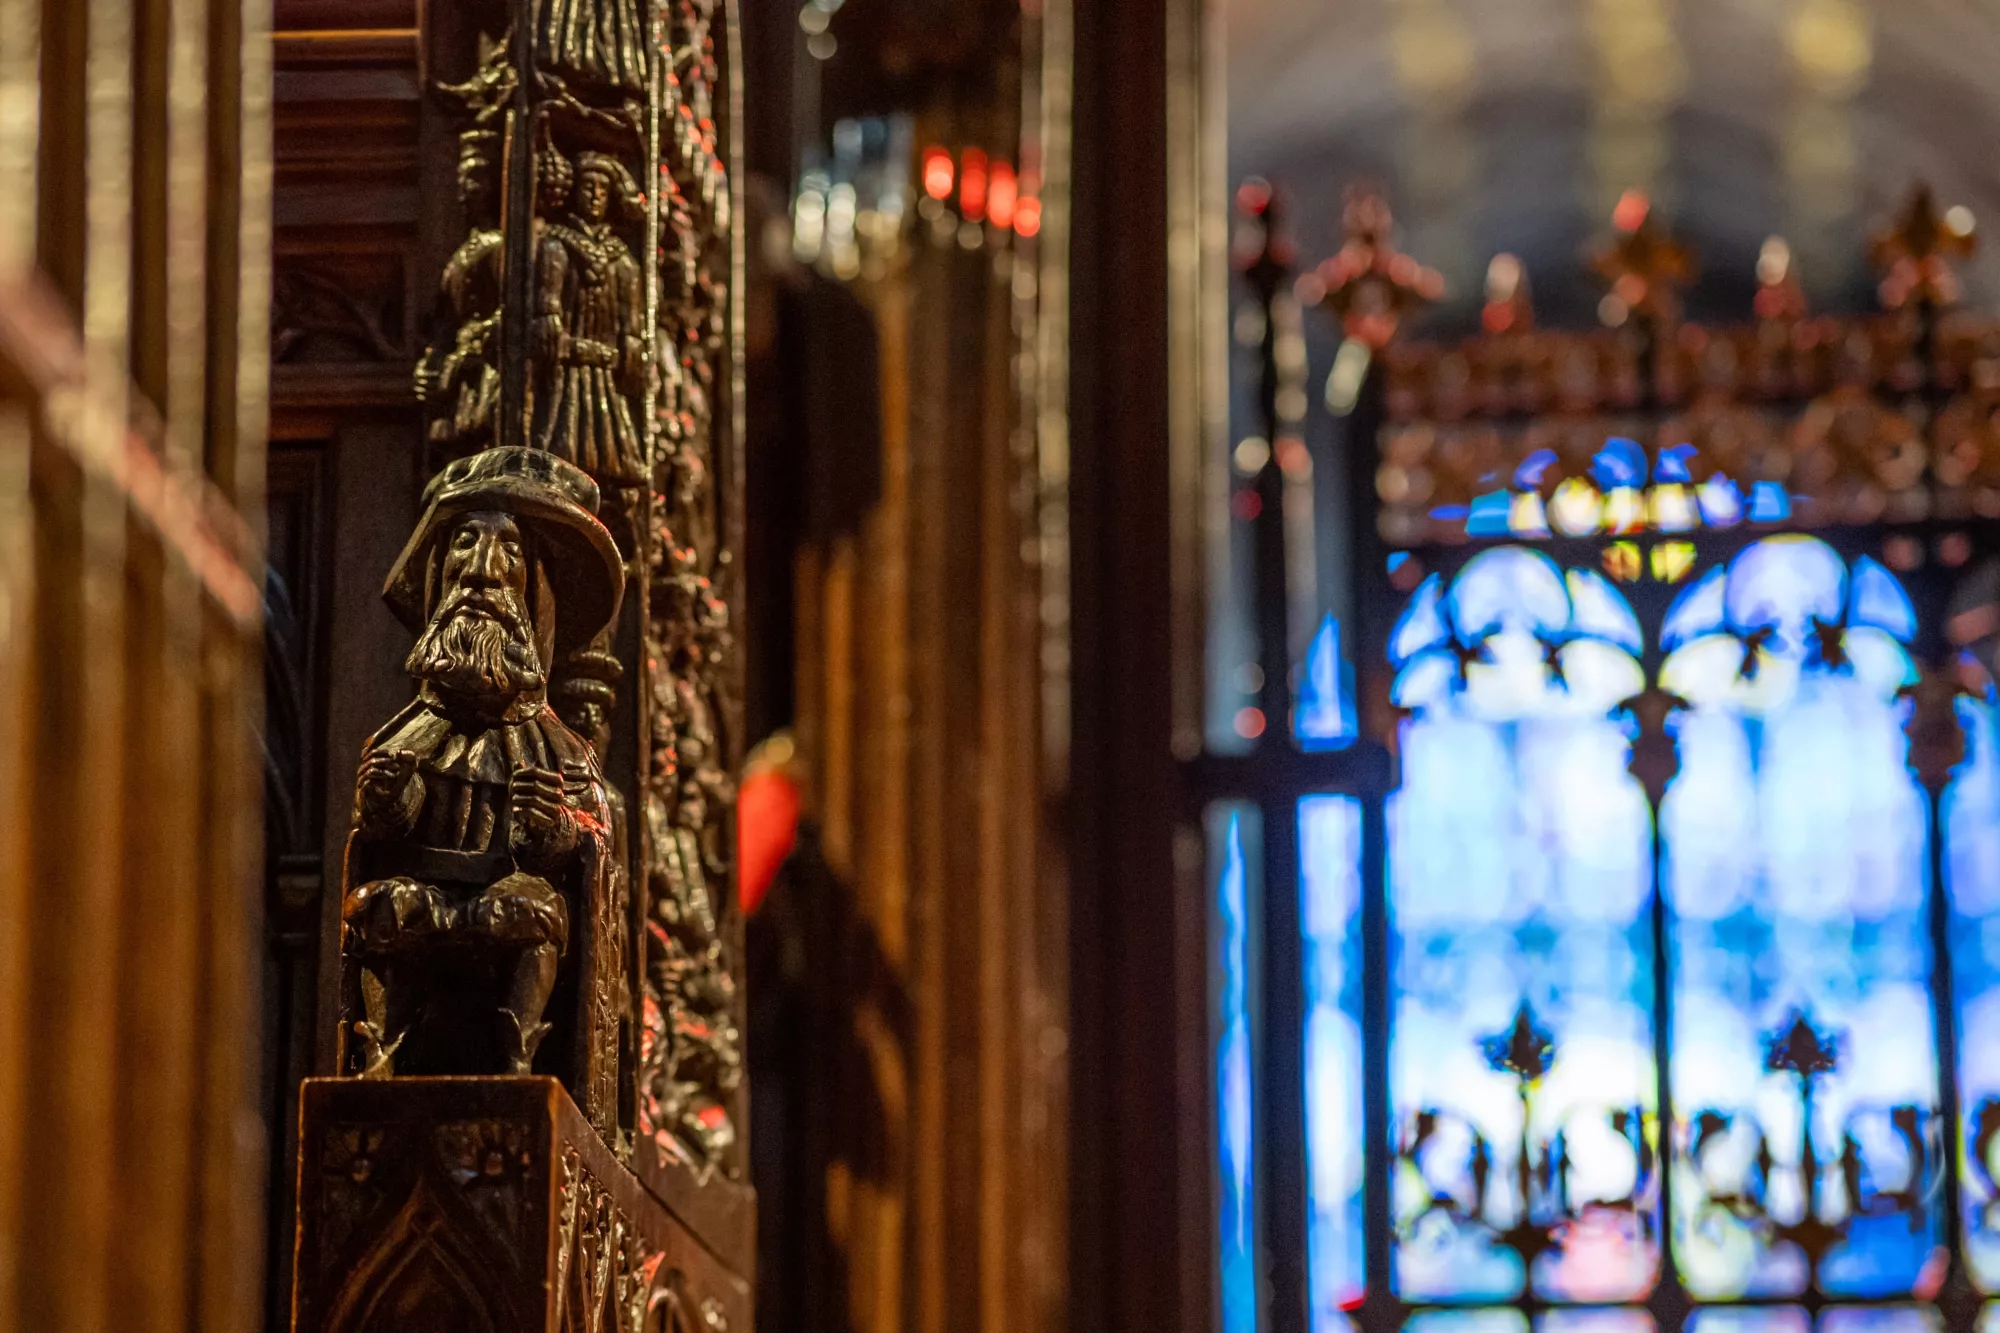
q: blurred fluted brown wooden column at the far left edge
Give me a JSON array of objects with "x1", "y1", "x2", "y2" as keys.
[{"x1": 0, "y1": 0, "x2": 268, "y2": 1333}]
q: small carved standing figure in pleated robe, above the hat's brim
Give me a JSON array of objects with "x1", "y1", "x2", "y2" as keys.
[{"x1": 534, "y1": 152, "x2": 648, "y2": 486}]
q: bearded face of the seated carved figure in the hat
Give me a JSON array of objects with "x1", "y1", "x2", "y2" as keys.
[{"x1": 406, "y1": 512, "x2": 544, "y2": 703}]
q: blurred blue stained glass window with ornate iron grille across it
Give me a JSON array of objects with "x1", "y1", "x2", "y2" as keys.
[{"x1": 1190, "y1": 171, "x2": 2000, "y2": 1333}]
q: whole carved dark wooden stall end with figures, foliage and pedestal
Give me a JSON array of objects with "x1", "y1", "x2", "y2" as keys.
[{"x1": 292, "y1": 0, "x2": 754, "y2": 1333}]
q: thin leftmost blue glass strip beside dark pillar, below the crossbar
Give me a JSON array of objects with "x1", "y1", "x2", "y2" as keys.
[{"x1": 1208, "y1": 805, "x2": 1258, "y2": 1333}]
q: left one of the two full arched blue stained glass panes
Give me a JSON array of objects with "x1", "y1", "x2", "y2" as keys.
[{"x1": 1388, "y1": 546, "x2": 1658, "y2": 1301}]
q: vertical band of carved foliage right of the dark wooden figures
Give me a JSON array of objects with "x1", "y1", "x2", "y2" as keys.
[{"x1": 640, "y1": 0, "x2": 742, "y2": 1173}]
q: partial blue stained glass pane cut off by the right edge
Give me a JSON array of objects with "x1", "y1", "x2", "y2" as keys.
[{"x1": 1942, "y1": 697, "x2": 2000, "y2": 1293}]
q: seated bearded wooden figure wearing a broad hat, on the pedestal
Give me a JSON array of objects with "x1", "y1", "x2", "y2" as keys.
[{"x1": 342, "y1": 448, "x2": 624, "y2": 1127}]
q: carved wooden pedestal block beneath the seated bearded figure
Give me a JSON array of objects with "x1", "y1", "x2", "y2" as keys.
[{"x1": 292, "y1": 1077, "x2": 750, "y2": 1333}]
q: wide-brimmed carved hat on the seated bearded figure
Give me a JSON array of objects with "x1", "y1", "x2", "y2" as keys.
[{"x1": 382, "y1": 446, "x2": 624, "y2": 654}]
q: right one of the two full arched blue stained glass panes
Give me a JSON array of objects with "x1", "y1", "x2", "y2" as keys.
[{"x1": 1660, "y1": 536, "x2": 1938, "y2": 1299}]
